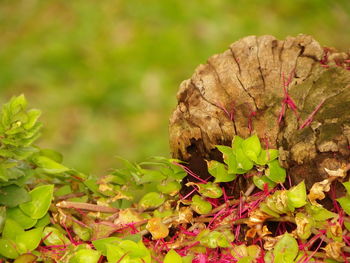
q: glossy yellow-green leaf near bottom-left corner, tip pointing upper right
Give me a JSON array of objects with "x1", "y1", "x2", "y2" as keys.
[{"x1": 16, "y1": 227, "x2": 43, "y2": 253}]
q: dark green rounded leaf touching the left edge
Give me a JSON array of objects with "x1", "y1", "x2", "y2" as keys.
[{"x1": 0, "y1": 184, "x2": 30, "y2": 207}]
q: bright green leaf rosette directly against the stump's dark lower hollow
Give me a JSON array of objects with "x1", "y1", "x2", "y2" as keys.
[{"x1": 208, "y1": 135, "x2": 286, "y2": 189}]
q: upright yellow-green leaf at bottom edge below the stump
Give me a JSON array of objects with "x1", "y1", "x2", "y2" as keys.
[{"x1": 273, "y1": 233, "x2": 299, "y2": 263}]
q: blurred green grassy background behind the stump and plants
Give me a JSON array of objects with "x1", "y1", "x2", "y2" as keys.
[{"x1": 0, "y1": 0, "x2": 350, "y2": 177}]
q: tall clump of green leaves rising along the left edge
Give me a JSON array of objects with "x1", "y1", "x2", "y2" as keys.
[{"x1": 0, "y1": 95, "x2": 82, "y2": 259}]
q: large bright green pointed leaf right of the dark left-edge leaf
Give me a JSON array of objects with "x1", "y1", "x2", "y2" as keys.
[{"x1": 19, "y1": 185, "x2": 54, "y2": 219}]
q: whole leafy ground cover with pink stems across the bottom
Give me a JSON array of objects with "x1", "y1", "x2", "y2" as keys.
[{"x1": 0, "y1": 95, "x2": 350, "y2": 263}]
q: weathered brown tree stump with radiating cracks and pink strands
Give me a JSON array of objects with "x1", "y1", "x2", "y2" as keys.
[{"x1": 169, "y1": 35, "x2": 350, "y2": 192}]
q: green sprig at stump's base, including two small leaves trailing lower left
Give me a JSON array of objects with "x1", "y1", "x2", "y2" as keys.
[{"x1": 189, "y1": 135, "x2": 286, "y2": 214}]
